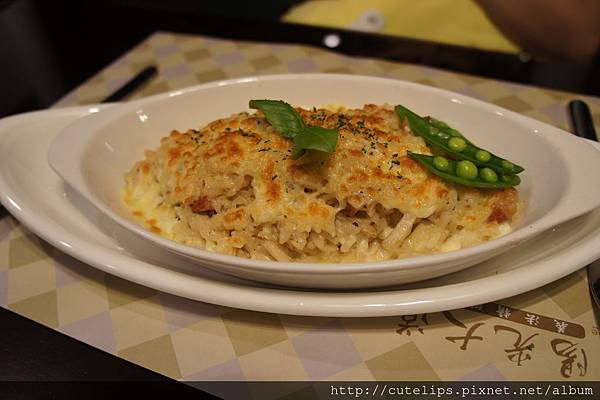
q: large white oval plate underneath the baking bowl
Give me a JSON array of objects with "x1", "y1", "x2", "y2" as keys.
[{"x1": 0, "y1": 107, "x2": 600, "y2": 317}]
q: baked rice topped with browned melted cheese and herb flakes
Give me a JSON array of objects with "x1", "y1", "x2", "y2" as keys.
[{"x1": 124, "y1": 104, "x2": 519, "y2": 262}]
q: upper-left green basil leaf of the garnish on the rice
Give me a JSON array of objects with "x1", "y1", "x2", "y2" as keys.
[{"x1": 250, "y1": 100, "x2": 304, "y2": 139}]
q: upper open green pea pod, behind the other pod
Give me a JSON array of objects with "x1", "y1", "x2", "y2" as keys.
[{"x1": 395, "y1": 105, "x2": 524, "y2": 175}]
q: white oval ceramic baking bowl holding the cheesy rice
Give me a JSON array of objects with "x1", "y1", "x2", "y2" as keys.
[{"x1": 48, "y1": 74, "x2": 600, "y2": 289}]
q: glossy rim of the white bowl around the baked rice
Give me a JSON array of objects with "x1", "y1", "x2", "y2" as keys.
[{"x1": 48, "y1": 73, "x2": 596, "y2": 275}]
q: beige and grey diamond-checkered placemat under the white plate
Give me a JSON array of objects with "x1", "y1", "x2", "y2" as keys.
[{"x1": 0, "y1": 32, "x2": 600, "y2": 386}]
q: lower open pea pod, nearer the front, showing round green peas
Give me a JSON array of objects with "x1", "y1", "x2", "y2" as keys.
[{"x1": 408, "y1": 151, "x2": 521, "y2": 189}]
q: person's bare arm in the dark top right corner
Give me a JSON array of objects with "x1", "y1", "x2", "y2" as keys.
[{"x1": 476, "y1": 0, "x2": 600, "y2": 62}]
